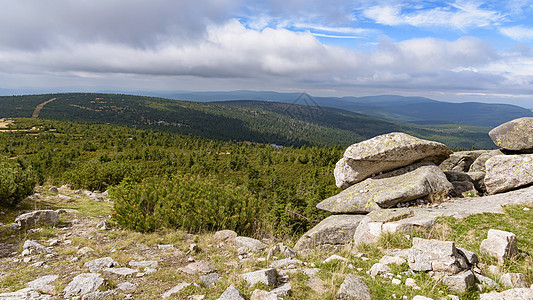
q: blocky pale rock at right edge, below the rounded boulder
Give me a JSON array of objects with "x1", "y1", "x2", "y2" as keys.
[{"x1": 485, "y1": 154, "x2": 533, "y2": 195}]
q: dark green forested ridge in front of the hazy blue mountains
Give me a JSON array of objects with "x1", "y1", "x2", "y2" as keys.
[{"x1": 0, "y1": 93, "x2": 494, "y2": 149}]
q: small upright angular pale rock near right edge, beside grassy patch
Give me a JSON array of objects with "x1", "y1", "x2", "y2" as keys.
[{"x1": 479, "y1": 229, "x2": 518, "y2": 264}]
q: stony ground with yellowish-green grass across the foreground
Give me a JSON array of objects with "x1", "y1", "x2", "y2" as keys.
[{"x1": 0, "y1": 187, "x2": 533, "y2": 299}]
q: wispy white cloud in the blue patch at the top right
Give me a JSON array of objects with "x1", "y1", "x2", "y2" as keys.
[{"x1": 363, "y1": 1, "x2": 503, "y2": 30}]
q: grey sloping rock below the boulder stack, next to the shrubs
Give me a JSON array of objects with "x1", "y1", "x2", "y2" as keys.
[{"x1": 294, "y1": 215, "x2": 364, "y2": 251}]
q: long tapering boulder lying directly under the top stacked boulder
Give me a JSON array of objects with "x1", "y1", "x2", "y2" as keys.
[{"x1": 316, "y1": 164, "x2": 453, "y2": 213}]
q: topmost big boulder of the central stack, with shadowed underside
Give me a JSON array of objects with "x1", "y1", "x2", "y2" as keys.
[{"x1": 335, "y1": 132, "x2": 452, "y2": 188}]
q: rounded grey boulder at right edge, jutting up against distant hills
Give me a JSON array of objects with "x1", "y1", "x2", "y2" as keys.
[{"x1": 489, "y1": 117, "x2": 533, "y2": 153}]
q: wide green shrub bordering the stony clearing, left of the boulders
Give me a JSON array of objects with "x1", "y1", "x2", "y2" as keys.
[{"x1": 110, "y1": 175, "x2": 261, "y2": 234}]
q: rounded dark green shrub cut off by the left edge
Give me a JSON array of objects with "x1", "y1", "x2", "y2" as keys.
[{"x1": 0, "y1": 158, "x2": 37, "y2": 207}]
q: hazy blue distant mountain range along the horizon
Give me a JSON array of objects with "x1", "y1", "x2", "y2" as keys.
[{"x1": 135, "y1": 90, "x2": 533, "y2": 127}]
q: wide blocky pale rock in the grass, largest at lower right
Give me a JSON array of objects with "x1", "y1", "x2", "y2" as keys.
[{"x1": 407, "y1": 238, "x2": 461, "y2": 274}]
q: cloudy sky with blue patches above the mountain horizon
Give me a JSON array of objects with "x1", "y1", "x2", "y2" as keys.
[{"x1": 0, "y1": 0, "x2": 533, "y2": 108}]
